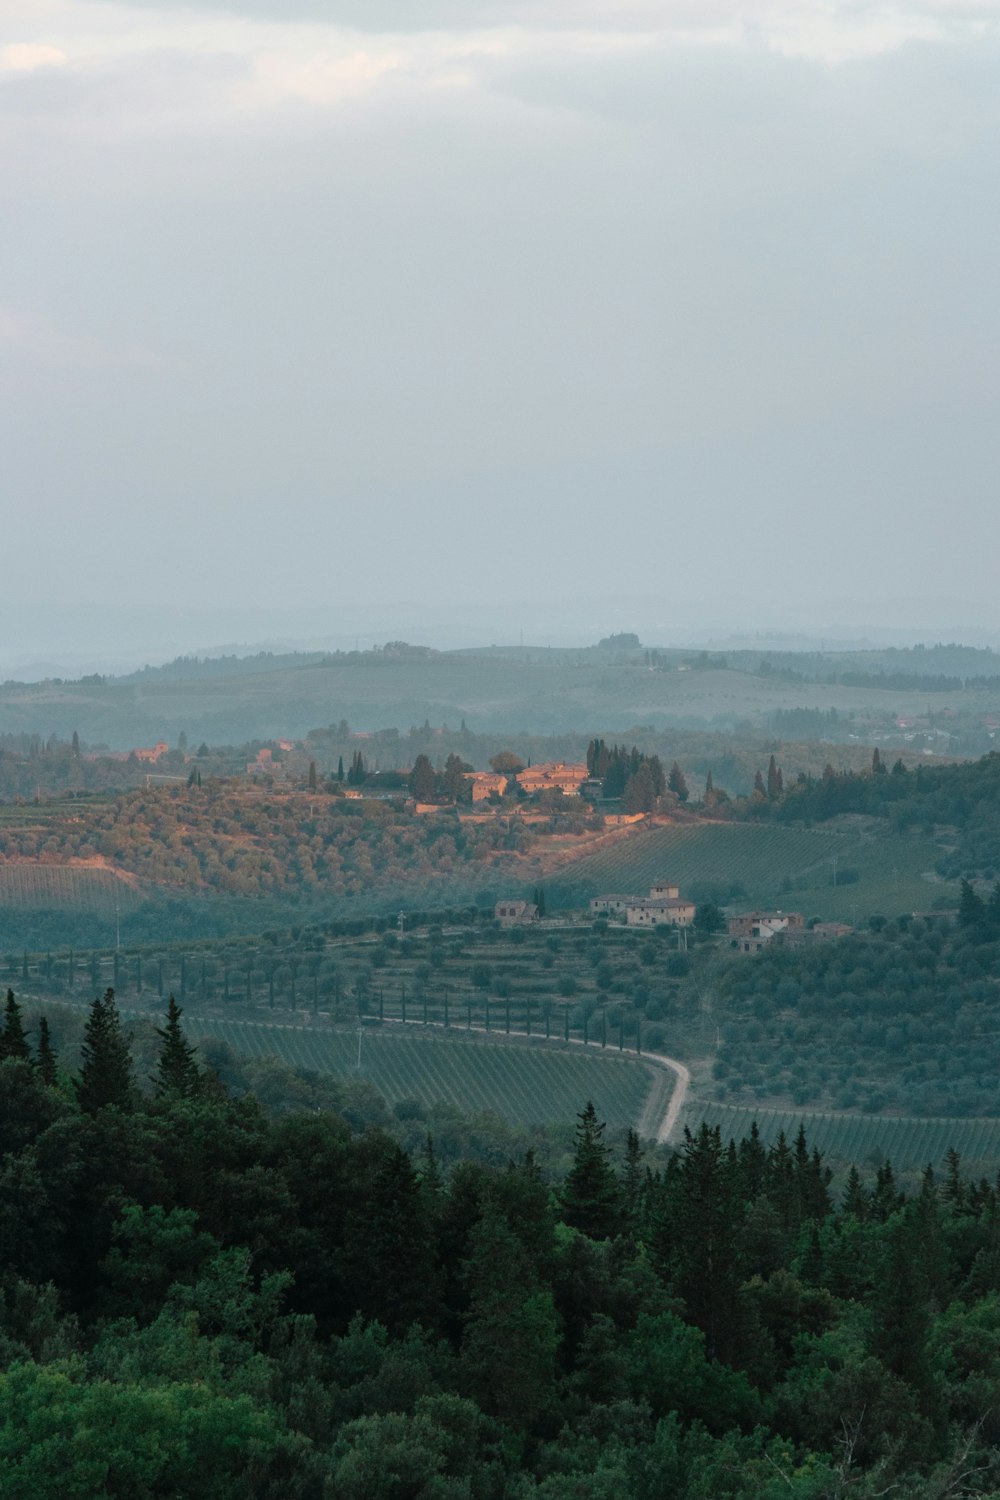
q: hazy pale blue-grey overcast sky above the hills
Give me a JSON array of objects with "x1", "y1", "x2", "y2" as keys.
[{"x1": 0, "y1": 0, "x2": 1000, "y2": 654}]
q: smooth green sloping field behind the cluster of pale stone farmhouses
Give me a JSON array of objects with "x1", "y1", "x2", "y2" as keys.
[{"x1": 547, "y1": 822, "x2": 957, "y2": 921}]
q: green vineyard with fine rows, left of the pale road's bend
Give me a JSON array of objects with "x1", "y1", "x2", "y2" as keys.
[{"x1": 184, "y1": 1017, "x2": 657, "y2": 1127}]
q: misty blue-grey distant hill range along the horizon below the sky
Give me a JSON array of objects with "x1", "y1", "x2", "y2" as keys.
[{"x1": 0, "y1": 638, "x2": 1000, "y2": 750}]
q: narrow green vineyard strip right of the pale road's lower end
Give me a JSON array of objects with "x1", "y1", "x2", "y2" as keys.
[{"x1": 681, "y1": 1100, "x2": 1000, "y2": 1175}]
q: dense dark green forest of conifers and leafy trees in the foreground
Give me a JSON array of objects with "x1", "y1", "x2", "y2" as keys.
[{"x1": 0, "y1": 995, "x2": 1000, "y2": 1500}]
